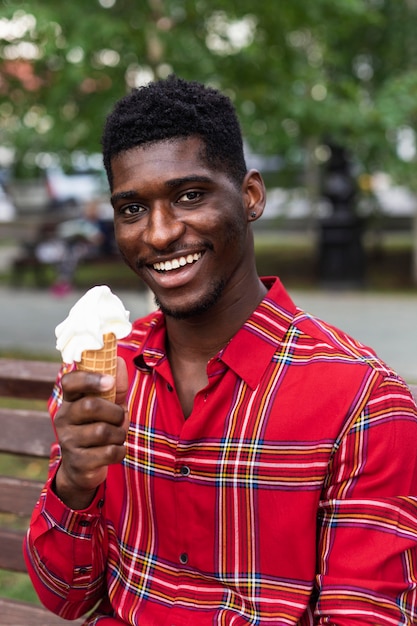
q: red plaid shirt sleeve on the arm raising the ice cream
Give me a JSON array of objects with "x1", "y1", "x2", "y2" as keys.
[{"x1": 23, "y1": 360, "x2": 107, "y2": 619}]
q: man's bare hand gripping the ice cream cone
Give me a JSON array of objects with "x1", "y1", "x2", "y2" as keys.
[{"x1": 55, "y1": 358, "x2": 128, "y2": 510}]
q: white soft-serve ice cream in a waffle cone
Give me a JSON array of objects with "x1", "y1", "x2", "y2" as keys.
[{"x1": 55, "y1": 285, "x2": 132, "y2": 400}]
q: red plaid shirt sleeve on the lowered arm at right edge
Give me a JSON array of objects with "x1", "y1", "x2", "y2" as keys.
[{"x1": 315, "y1": 372, "x2": 417, "y2": 626}]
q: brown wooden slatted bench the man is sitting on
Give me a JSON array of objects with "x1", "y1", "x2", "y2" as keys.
[{"x1": 0, "y1": 359, "x2": 417, "y2": 626}]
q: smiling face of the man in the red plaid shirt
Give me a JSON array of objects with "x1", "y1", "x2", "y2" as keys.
[{"x1": 112, "y1": 137, "x2": 253, "y2": 318}]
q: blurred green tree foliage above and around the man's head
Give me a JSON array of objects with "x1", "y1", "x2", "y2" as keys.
[{"x1": 0, "y1": 0, "x2": 417, "y2": 182}]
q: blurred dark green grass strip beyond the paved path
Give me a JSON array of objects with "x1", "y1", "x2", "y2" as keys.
[{"x1": 0, "y1": 228, "x2": 416, "y2": 291}]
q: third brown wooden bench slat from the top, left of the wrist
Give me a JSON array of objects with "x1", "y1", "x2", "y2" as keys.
[{"x1": 0, "y1": 476, "x2": 43, "y2": 517}]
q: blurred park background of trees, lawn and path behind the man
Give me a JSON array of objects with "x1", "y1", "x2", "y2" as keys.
[{"x1": 0, "y1": 0, "x2": 417, "y2": 370}]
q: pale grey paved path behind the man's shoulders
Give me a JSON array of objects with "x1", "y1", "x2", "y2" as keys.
[{"x1": 0, "y1": 287, "x2": 417, "y2": 383}]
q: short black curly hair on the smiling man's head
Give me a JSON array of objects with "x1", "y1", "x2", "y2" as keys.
[{"x1": 102, "y1": 75, "x2": 247, "y2": 188}]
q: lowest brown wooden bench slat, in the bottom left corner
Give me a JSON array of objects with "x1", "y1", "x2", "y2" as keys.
[{"x1": 0, "y1": 598, "x2": 84, "y2": 626}]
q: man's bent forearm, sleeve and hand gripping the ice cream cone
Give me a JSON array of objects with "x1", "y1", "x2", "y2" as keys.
[{"x1": 24, "y1": 360, "x2": 127, "y2": 619}]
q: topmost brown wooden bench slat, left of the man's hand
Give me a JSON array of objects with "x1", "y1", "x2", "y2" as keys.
[{"x1": 0, "y1": 359, "x2": 60, "y2": 400}]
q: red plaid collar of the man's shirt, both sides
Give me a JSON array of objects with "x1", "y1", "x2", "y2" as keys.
[{"x1": 134, "y1": 277, "x2": 296, "y2": 388}]
